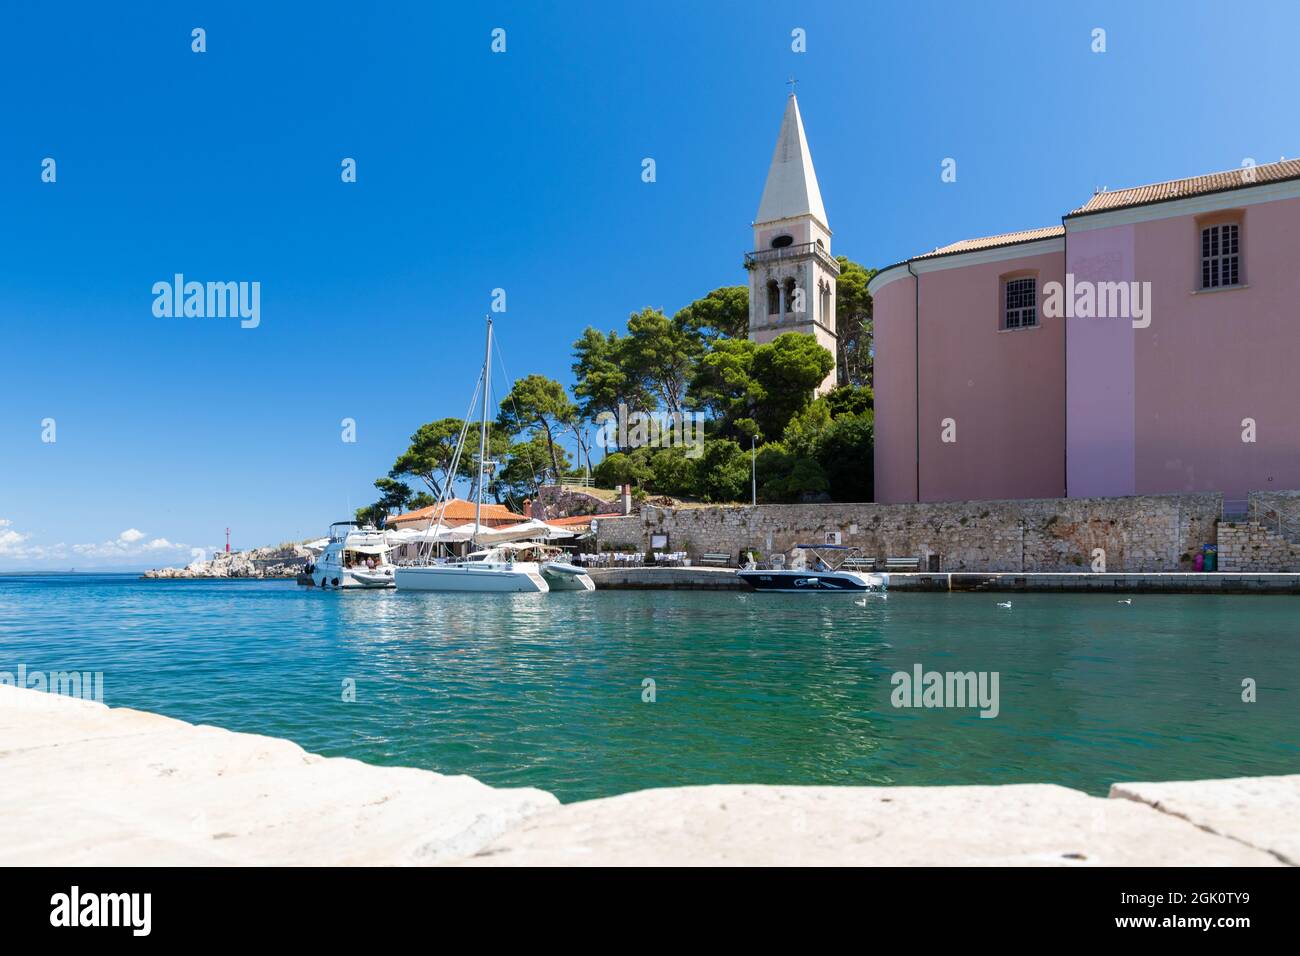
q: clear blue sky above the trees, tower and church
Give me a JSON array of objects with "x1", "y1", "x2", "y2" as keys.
[{"x1": 0, "y1": 0, "x2": 1300, "y2": 570}]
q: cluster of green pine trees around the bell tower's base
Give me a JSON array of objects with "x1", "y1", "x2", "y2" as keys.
[{"x1": 358, "y1": 256, "x2": 875, "y2": 524}]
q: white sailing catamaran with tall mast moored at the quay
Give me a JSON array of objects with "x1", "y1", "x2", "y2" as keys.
[{"x1": 394, "y1": 316, "x2": 550, "y2": 592}]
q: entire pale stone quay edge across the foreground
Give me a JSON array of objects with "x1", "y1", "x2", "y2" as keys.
[{"x1": 0, "y1": 685, "x2": 1300, "y2": 866}]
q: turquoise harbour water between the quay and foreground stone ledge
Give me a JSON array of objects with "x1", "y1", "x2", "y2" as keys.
[{"x1": 0, "y1": 575, "x2": 1300, "y2": 801}]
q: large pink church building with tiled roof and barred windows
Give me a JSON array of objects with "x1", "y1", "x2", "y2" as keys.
[{"x1": 868, "y1": 160, "x2": 1300, "y2": 502}]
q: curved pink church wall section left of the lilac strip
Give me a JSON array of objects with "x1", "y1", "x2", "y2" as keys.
[{"x1": 875, "y1": 252, "x2": 1065, "y2": 502}]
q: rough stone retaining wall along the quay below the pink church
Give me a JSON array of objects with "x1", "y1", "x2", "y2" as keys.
[{"x1": 634, "y1": 494, "x2": 1222, "y2": 571}]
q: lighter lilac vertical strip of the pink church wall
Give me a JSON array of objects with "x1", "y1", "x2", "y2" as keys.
[{"x1": 1066, "y1": 225, "x2": 1136, "y2": 498}]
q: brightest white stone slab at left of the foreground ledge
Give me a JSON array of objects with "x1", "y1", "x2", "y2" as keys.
[{"x1": 0, "y1": 685, "x2": 558, "y2": 865}]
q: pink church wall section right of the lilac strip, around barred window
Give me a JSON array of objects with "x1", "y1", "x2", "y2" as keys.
[{"x1": 1128, "y1": 199, "x2": 1300, "y2": 498}]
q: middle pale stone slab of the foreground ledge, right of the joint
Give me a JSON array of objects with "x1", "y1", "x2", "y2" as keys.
[{"x1": 463, "y1": 784, "x2": 1279, "y2": 866}]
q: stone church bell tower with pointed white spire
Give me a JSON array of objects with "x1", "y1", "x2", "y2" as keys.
[{"x1": 745, "y1": 92, "x2": 840, "y2": 395}]
